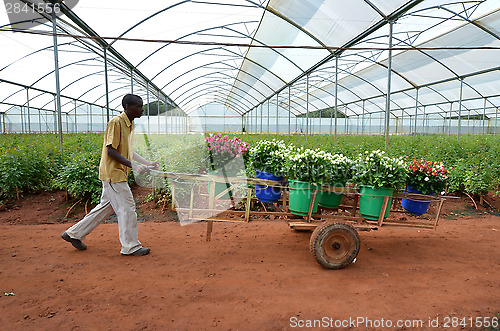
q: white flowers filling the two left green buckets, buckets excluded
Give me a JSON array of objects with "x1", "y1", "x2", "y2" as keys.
[{"x1": 284, "y1": 148, "x2": 352, "y2": 185}]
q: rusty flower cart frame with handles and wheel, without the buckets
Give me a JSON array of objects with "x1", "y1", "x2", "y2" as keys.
[{"x1": 152, "y1": 171, "x2": 446, "y2": 269}]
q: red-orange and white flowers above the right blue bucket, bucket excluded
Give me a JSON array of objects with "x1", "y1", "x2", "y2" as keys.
[{"x1": 406, "y1": 159, "x2": 449, "y2": 194}]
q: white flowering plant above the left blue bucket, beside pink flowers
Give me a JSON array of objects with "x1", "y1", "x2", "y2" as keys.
[{"x1": 248, "y1": 139, "x2": 294, "y2": 176}]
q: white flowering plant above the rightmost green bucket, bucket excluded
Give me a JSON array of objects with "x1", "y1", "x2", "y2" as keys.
[{"x1": 353, "y1": 150, "x2": 408, "y2": 189}]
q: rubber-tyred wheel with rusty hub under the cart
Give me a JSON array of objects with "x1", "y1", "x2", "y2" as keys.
[{"x1": 309, "y1": 222, "x2": 360, "y2": 269}]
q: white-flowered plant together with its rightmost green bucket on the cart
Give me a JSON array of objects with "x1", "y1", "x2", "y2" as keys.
[{"x1": 353, "y1": 150, "x2": 407, "y2": 220}]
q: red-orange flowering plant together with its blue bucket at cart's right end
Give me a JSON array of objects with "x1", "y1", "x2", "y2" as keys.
[{"x1": 401, "y1": 159, "x2": 449, "y2": 215}]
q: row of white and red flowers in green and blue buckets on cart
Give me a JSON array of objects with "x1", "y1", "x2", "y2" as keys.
[{"x1": 203, "y1": 137, "x2": 448, "y2": 220}]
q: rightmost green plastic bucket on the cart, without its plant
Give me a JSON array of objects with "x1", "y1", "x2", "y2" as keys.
[{"x1": 359, "y1": 185, "x2": 394, "y2": 221}]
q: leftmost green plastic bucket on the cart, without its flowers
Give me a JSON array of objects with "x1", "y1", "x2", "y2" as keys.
[{"x1": 288, "y1": 180, "x2": 319, "y2": 216}]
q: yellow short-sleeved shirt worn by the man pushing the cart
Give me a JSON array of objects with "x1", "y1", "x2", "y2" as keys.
[{"x1": 99, "y1": 112, "x2": 134, "y2": 183}]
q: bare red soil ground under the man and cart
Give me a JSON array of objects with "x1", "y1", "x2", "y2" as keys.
[{"x1": 0, "y1": 189, "x2": 500, "y2": 330}]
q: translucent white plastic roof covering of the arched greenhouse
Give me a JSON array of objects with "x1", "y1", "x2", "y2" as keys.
[{"x1": 0, "y1": 0, "x2": 500, "y2": 120}]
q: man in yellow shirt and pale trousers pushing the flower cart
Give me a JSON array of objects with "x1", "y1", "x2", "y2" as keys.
[{"x1": 61, "y1": 94, "x2": 159, "y2": 256}]
